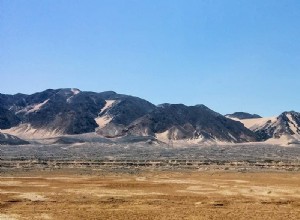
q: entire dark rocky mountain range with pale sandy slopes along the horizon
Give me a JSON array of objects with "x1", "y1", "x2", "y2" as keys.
[{"x1": 0, "y1": 88, "x2": 300, "y2": 144}]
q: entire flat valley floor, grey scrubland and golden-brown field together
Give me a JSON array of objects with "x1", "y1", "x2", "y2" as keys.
[{"x1": 0, "y1": 144, "x2": 300, "y2": 220}]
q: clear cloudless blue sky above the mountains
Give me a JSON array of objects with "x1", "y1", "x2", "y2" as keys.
[{"x1": 0, "y1": 0, "x2": 300, "y2": 116}]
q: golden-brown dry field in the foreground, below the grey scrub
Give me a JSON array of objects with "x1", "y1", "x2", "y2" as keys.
[{"x1": 0, "y1": 171, "x2": 300, "y2": 220}]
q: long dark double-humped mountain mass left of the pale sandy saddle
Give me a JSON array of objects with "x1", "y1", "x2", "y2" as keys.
[{"x1": 0, "y1": 89, "x2": 256, "y2": 142}]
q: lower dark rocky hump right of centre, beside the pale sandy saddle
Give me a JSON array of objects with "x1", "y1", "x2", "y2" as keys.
[{"x1": 100, "y1": 104, "x2": 256, "y2": 142}]
